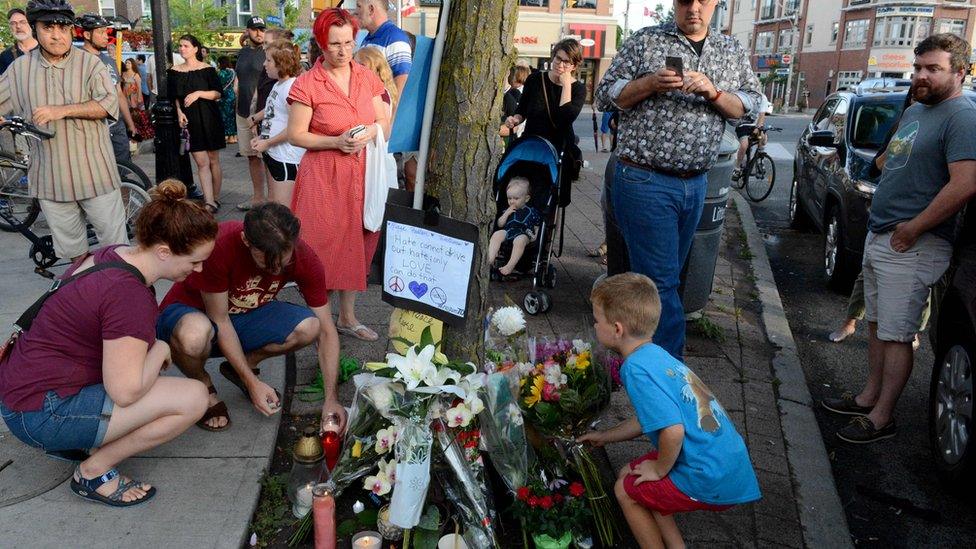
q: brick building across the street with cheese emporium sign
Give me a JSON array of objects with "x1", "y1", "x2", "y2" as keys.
[{"x1": 723, "y1": 0, "x2": 976, "y2": 108}]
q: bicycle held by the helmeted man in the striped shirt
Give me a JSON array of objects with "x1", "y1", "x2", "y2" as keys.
[{"x1": 0, "y1": 118, "x2": 151, "y2": 278}]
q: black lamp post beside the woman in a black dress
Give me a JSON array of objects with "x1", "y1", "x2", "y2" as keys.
[{"x1": 150, "y1": 0, "x2": 181, "y2": 182}]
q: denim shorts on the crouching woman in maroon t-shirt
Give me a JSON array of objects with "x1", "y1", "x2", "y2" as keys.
[{"x1": 0, "y1": 383, "x2": 115, "y2": 452}]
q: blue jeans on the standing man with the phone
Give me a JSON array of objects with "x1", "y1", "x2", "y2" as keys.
[{"x1": 611, "y1": 162, "x2": 708, "y2": 360}]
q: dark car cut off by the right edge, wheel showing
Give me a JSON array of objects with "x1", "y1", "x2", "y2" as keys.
[{"x1": 928, "y1": 206, "x2": 976, "y2": 493}]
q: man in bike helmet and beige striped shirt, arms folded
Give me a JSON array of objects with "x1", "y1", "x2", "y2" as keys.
[{"x1": 0, "y1": 0, "x2": 128, "y2": 259}]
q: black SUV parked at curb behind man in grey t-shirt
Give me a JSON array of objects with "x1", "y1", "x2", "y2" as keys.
[{"x1": 789, "y1": 89, "x2": 976, "y2": 291}]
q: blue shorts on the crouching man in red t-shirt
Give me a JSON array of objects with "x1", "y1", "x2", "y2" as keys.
[{"x1": 156, "y1": 301, "x2": 315, "y2": 357}]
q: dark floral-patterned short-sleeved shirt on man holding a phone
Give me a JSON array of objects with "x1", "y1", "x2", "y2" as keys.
[{"x1": 596, "y1": 24, "x2": 762, "y2": 172}]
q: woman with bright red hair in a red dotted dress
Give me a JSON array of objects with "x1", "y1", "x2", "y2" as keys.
[{"x1": 288, "y1": 8, "x2": 390, "y2": 341}]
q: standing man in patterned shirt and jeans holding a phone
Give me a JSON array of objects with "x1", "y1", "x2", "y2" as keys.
[{"x1": 596, "y1": 0, "x2": 762, "y2": 360}]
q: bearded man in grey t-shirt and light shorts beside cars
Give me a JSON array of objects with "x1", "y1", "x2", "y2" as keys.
[{"x1": 823, "y1": 34, "x2": 976, "y2": 443}]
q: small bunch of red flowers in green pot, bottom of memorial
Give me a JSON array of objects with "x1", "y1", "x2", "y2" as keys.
[{"x1": 513, "y1": 480, "x2": 590, "y2": 547}]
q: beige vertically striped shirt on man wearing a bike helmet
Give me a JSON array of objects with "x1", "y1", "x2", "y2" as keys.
[{"x1": 0, "y1": 47, "x2": 120, "y2": 202}]
